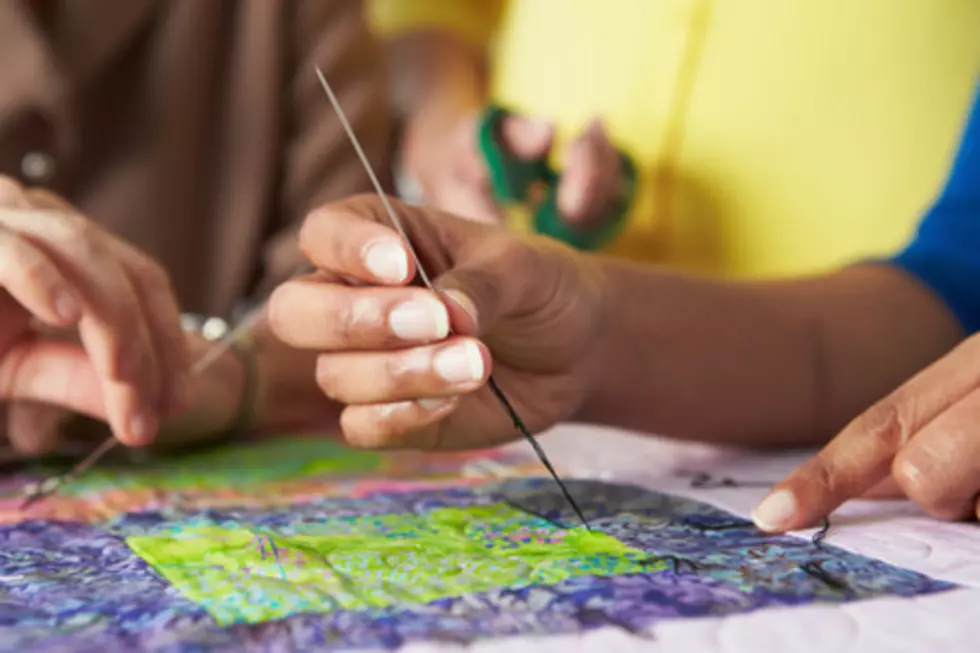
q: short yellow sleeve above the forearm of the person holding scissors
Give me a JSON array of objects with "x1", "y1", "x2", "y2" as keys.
[{"x1": 365, "y1": 0, "x2": 504, "y2": 48}]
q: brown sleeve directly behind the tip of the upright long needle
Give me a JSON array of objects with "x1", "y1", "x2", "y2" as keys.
[{"x1": 262, "y1": 0, "x2": 393, "y2": 290}]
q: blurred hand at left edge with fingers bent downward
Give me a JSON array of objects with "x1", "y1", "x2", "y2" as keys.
[{"x1": 0, "y1": 177, "x2": 187, "y2": 450}]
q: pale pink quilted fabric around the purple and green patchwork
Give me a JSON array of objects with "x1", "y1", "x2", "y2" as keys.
[{"x1": 404, "y1": 425, "x2": 980, "y2": 653}]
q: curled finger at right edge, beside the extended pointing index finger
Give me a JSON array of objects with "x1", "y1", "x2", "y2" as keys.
[{"x1": 892, "y1": 391, "x2": 980, "y2": 519}]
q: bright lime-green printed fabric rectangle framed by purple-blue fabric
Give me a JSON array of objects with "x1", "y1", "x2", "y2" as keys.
[{"x1": 126, "y1": 505, "x2": 652, "y2": 626}]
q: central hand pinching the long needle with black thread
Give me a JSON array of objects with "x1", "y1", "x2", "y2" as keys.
[{"x1": 269, "y1": 197, "x2": 602, "y2": 449}]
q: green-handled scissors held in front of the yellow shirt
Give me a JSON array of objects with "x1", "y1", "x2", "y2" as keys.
[{"x1": 478, "y1": 104, "x2": 637, "y2": 250}]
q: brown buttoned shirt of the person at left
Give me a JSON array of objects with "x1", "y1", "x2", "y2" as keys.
[{"x1": 0, "y1": 0, "x2": 392, "y2": 314}]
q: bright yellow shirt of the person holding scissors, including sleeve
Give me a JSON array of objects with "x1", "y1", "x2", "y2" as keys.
[{"x1": 370, "y1": 0, "x2": 980, "y2": 277}]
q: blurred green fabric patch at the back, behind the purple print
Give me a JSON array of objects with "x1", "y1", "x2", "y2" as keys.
[{"x1": 52, "y1": 438, "x2": 381, "y2": 496}]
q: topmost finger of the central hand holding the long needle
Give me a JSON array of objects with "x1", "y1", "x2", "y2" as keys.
[{"x1": 299, "y1": 197, "x2": 415, "y2": 285}]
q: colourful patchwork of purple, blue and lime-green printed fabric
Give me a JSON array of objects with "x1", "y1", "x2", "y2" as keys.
[{"x1": 0, "y1": 437, "x2": 955, "y2": 653}]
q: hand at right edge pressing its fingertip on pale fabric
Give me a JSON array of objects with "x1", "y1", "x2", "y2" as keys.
[{"x1": 754, "y1": 336, "x2": 980, "y2": 531}]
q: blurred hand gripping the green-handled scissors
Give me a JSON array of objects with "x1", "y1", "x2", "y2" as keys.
[{"x1": 404, "y1": 102, "x2": 623, "y2": 229}]
